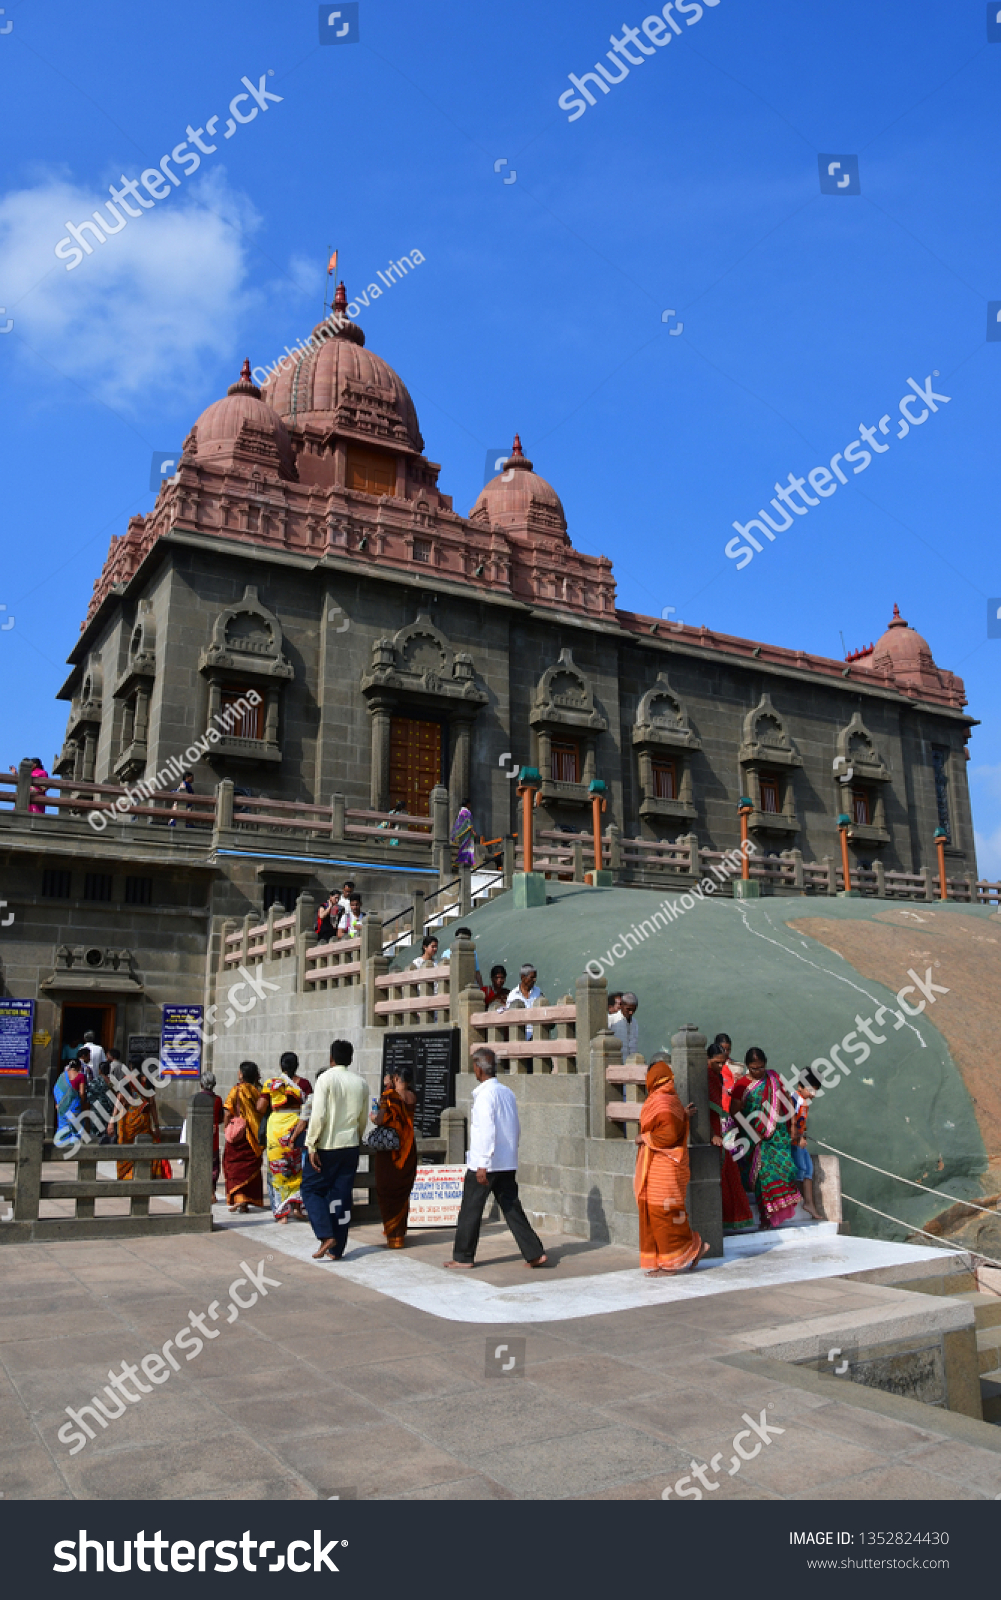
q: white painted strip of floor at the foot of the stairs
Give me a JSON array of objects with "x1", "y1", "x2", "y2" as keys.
[{"x1": 222, "y1": 1218, "x2": 947, "y2": 1323}]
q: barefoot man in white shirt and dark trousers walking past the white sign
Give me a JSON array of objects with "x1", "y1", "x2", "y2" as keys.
[{"x1": 445, "y1": 1046, "x2": 547, "y2": 1270}]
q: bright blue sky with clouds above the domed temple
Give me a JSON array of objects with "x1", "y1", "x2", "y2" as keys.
[{"x1": 0, "y1": 0, "x2": 1001, "y2": 878}]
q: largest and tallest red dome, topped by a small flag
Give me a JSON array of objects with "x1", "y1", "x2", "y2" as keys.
[{"x1": 264, "y1": 283, "x2": 424, "y2": 453}]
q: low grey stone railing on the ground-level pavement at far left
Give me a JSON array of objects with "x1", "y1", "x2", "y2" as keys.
[{"x1": 0, "y1": 1094, "x2": 216, "y2": 1245}]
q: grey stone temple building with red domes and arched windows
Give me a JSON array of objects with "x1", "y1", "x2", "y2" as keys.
[{"x1": 0, "y1": 285, "x2": 975, "y2": 1100}]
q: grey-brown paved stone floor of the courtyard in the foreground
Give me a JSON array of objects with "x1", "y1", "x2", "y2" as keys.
[{"x1": 0, "y1": 1218, "x2": 1001, "y2": 1501}]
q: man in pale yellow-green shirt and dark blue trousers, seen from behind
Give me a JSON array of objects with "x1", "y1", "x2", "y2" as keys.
[{"x1": 302, "y1": 1038, "x2": 368, "y2": 1261}]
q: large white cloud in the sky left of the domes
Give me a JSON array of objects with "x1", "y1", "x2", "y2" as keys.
[{"x1": 0, "y1": 168, "x2": 261, "y2": 405}]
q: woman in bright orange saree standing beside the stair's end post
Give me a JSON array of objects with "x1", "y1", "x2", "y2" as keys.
[{"x1": 633, "y1": 1061, "x2": 708, "y2": 1278}]
